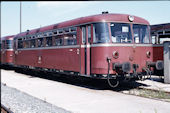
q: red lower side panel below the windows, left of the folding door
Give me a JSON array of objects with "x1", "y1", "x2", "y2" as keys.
[{"x1": 15, "y1": 48, "x2": 80, "y2": 72}]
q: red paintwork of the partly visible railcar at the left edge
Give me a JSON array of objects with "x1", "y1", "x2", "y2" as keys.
[{"x1": 1, "y1": 35, "x2": 14, "y2": 64}]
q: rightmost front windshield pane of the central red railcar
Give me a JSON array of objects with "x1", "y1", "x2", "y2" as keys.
[{"x1": 133, "y1": 24, "x2": 150, "y2": 43}]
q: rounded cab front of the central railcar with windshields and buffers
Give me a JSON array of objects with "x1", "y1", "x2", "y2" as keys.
[{"x1": 91, "y1": 15, "x2": 162, "y2": 86}]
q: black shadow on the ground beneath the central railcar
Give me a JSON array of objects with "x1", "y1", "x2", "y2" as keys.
[{"x1": 11, "y1": 68, "x2": 146, "y2": 92}]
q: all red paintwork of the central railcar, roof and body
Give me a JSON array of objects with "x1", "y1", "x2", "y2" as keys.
[{"x1": 15, "y1": 14, "x2": 154, "y2": 75}]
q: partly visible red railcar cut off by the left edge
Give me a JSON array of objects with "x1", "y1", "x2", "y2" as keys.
[{"x1": 1, "y1": 35, "x2": 14, "y2": 66}]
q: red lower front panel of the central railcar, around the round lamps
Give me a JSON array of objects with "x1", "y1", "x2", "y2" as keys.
[{"x1": 91, "y1": 44, "x2": 152, "y2": 74}]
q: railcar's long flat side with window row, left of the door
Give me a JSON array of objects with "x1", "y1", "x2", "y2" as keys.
[{"x1": 15, "y1": 27, "x2": 80, "y2": 74}]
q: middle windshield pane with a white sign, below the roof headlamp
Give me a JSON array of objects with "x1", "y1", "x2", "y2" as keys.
[{"x1": 110, "y1": 23, "x2": 132, "y2": 43}]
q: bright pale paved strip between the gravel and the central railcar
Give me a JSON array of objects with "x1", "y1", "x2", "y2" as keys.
[{"x1": 1, "y1": 70, "x2": 170, "y2": 113}]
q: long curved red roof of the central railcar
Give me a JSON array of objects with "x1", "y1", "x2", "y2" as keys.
[{"x1": 16, "y1": 14, "x2": 149, "y2": 36}]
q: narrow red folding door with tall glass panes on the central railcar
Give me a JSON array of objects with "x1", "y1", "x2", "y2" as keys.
[{"x1": 80, "y1": 25, "x2": 91, "y2": 76}]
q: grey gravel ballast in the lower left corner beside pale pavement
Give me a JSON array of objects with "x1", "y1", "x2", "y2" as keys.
[{"x1": 1, "y1": 83, "x2": 71, "y2": 113}]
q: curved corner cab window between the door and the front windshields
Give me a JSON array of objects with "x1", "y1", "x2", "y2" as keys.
[{"x1": 93, "y1": 22, "x2": 110, "y2": 43}]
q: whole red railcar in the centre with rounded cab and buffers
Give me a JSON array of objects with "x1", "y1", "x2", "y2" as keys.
[{"x1": 14, "y1": 14, "x2": 162, "y2": 87}]
